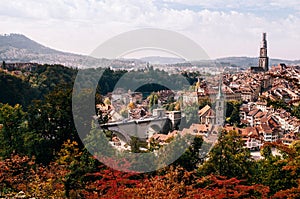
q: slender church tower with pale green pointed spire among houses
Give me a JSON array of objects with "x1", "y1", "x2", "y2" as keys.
[{"x1": 215, "y1": 76, "x2": 225, "y2": 126}]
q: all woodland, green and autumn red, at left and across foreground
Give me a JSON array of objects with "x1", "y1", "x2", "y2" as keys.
[{"x1": 0, "y1": 65, "x2": 300, "y2": 198}]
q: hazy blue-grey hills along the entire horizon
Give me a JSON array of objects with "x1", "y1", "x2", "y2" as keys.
[{"x1": 0, "y1": 34, "x2": 300, "y2": 68}]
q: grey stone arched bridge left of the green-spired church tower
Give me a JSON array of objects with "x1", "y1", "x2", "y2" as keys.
[{"x1": 100, "y1": 117, "x2": 168, "y2": 143}]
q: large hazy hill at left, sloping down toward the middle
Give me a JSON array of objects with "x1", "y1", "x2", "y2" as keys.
[{"x1": 0, "y1": 34, "x2": 141, "y2": 68}]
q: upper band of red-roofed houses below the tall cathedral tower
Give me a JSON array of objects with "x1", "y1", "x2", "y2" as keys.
[{"x1": 183, "y1": 64, "x2": 300, "y2": 103}]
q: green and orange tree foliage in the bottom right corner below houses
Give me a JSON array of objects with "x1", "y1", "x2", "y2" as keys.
[{"x1": 250, "y1": 142, "x2": 300, "y2": 195}]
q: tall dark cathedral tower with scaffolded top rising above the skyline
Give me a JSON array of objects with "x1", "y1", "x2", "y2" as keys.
[{"x1": 251, "y1": 33, "x2": 269, "y2": 73}]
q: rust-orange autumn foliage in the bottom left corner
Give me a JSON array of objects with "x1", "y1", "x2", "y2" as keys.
[{"x1": 0, "y1": 155, "x2": 67, "y2": 198}]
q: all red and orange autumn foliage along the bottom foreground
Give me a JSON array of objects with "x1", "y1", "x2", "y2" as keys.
[{"x1": 0, "y1": 149, "x2": 300, "y2": 199}]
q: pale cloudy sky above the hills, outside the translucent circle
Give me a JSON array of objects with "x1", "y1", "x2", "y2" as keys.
[{"x1": 0, "y1": 0, "x2": 300, "y2": 59}]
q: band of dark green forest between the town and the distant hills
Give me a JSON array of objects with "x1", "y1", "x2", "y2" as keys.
[{"x1": 0, "y1": 65, "x2": 199, "y2": 108}]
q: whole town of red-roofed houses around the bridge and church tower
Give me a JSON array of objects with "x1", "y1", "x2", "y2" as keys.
[{"x1": 99, "y1": 64, "x2": 300, "y2": 150}]
